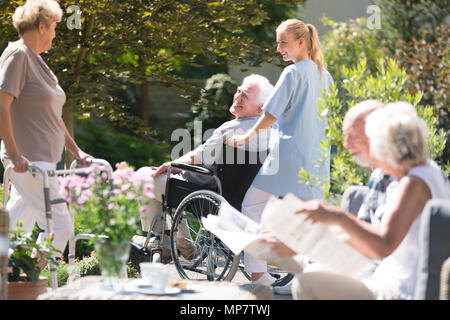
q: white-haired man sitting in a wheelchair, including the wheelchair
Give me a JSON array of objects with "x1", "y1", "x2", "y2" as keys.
[{"x1": 132, "y1": 74, "x2": 273, "y2": 280}]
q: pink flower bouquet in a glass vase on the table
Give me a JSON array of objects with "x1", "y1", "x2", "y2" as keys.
[{"x1": 60, "y1": 162, "x2": 154, "y2": 291}]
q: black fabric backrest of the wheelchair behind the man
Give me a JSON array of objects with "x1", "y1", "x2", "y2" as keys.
[{"x1": 217, "y1": 144, "x2": 267, "y2": 211}]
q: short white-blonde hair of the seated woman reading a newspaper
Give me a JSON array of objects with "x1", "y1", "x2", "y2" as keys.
[{"x1": 365, "y1": 102, "x2": 428, "y2": 171}]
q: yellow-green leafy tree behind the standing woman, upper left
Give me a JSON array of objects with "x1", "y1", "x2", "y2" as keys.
[{"x1": 0, "y1": 0, "x2": 302, "y2": 168}]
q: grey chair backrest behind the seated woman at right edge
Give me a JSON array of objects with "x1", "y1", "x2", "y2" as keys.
[{"x1": 414, "y1": 199, "x2": 450, "y2": 300}]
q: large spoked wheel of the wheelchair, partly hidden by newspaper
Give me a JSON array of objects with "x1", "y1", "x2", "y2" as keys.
[{"x1": 170, "y1": 190, "x2": 239, "y2": 281}]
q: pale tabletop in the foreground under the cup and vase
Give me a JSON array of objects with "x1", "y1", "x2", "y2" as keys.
[{"x1": 38, "y1": 276, "x2": 273, "y2": 300}]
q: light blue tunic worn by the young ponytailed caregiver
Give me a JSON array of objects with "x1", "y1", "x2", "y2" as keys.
[{"x1": 252, "y1": 60, "x2": 333, "y2": 198}]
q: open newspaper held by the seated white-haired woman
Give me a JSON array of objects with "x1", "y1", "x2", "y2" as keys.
[{"x1": 202, "y1": 193, "x2": 375, "y2": 278}]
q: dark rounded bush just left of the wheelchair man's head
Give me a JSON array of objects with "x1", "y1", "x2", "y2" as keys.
[{"x1": 186, "y1": 73, "x2": 237, "y2": 130}]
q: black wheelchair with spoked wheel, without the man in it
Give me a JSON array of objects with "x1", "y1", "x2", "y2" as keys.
[{"x1": 132, "y1": 144, "x2": 292, "y2": 285}]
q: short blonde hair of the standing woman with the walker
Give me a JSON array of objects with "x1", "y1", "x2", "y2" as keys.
[{"x1": 13, "y1": 0, "x2": 63, "y2": 34}]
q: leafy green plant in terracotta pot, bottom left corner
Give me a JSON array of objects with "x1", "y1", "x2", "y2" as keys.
[{"x1": 8, "y1": 221, "x2": 60, "y2": 300}]
